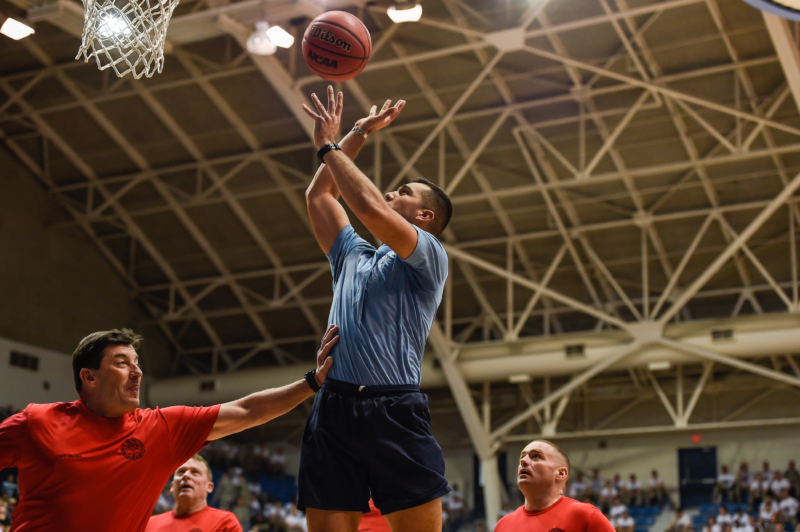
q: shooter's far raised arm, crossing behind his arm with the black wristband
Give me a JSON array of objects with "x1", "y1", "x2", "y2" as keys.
[{"x1": 306, "y1": 88, "x2": 402, "y2": 255}]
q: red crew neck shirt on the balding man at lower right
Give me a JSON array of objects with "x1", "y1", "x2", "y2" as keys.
[{"x1": 494, "y1": 496, "x2": 614, "y2": 532}]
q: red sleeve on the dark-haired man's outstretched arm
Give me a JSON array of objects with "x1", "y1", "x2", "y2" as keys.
[{"x1": 159, "y1": 405, "x2": 219, "y2": 467}]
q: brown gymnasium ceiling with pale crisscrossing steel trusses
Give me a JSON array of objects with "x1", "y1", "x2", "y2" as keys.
[{"x1": 0, "y1": 0, "x2": 800, "y2": 394}]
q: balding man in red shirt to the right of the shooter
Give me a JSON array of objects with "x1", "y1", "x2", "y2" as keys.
[{"x1": 494, "y1": 440, "x2": 614, "y2": 532}]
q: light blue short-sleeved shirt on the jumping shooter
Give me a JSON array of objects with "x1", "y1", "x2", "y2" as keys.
[{"x1": 328, "y1": 225, "x2": 447, "y2": 386}]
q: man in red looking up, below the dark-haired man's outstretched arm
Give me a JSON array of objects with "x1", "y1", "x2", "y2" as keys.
[{"x1": 145, "y1": 454, "x2": 242, "y2": 532}]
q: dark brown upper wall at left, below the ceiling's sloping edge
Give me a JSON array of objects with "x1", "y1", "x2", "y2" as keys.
[{"x1": 0, "y1": 148, "x2": 169, "y2": 404}]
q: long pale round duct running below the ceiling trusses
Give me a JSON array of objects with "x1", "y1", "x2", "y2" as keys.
[{"x1": 147, "y1": 314, "x2": 800, "y2": 406}]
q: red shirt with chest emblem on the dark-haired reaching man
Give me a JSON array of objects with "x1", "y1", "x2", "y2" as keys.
[{"x1": 0, "y1": 399, "x2": 219, "y2": 532}]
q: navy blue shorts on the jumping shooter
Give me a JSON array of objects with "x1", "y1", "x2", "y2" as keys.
[{"x1": 297, "y1": 379, "x2": 450, "y2": 515}]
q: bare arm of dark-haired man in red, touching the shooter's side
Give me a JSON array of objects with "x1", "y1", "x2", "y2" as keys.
[{"x1": 208, "y1": 325, "x2": 339, "y2": 440}]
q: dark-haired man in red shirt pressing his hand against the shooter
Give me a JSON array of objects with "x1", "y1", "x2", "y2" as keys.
[{"x1": 0, "y1": 326, "x2": 338, "y2": 532}]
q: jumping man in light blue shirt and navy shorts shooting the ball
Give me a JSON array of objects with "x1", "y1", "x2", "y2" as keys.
[{"x1": 298, "y1": 87, "x2": 452, "y2": 532}]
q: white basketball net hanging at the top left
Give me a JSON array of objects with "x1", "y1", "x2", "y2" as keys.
[{"x1": 75, "y1": 0, "x2": 179, "y2": 79}]
